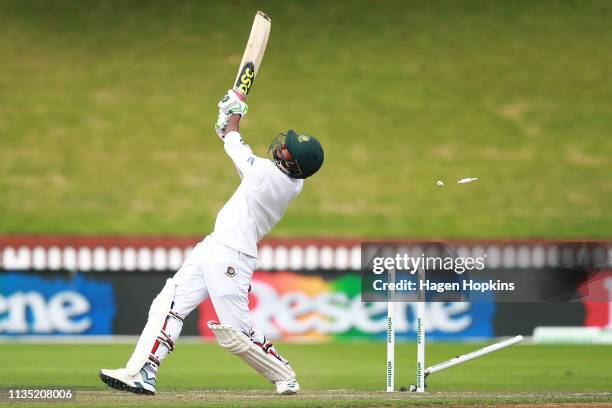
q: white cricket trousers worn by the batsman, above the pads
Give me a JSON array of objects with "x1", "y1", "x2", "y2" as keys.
[{"x1": 172, "y1": 235, "x2": 257, "y2": 334}]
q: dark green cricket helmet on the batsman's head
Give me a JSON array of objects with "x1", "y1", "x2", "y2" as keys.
[{"x1": 268, "y1": 129, "x2": 324, "y2": 179}]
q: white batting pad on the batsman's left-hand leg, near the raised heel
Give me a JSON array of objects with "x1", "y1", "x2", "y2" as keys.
[{"x1": 125, "y1": 278, "x2": 176, "y2": 376}]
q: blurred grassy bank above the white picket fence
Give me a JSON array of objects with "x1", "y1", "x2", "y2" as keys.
[{"x1": 0, "y1": 0, "x2": 612, "y2": 238}]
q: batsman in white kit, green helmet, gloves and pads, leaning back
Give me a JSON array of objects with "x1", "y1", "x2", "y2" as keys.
[{"x1": 100, "y1": 90, "x2": 323, "y2": 395}]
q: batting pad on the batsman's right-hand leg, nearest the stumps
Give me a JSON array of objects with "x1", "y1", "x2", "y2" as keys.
[{"x1": 208, "y1": 321, "x2": 295, "y2": 383}]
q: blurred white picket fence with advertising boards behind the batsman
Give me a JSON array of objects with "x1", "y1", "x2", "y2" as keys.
[{"x1": 0, "y1": 236, "x2": 612, "y2": 341}]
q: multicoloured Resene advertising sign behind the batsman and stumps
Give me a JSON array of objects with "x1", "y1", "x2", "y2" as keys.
[{"x1": 198, "y1": 272, "x2": 496, "y2": 340}]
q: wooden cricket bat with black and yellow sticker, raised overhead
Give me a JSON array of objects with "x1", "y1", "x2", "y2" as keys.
[{"x1": 234, "y1": 11, "x2": 272, "y2": 99}]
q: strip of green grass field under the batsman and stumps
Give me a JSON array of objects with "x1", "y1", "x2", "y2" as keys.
[{"x1": 0, "y1": 343, "x2": 612, "y2": 407}]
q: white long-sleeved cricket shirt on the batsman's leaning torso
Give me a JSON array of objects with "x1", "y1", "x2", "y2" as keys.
[{"x1": 212, "y1": 132, "x2": 304, "y2": 257}]
